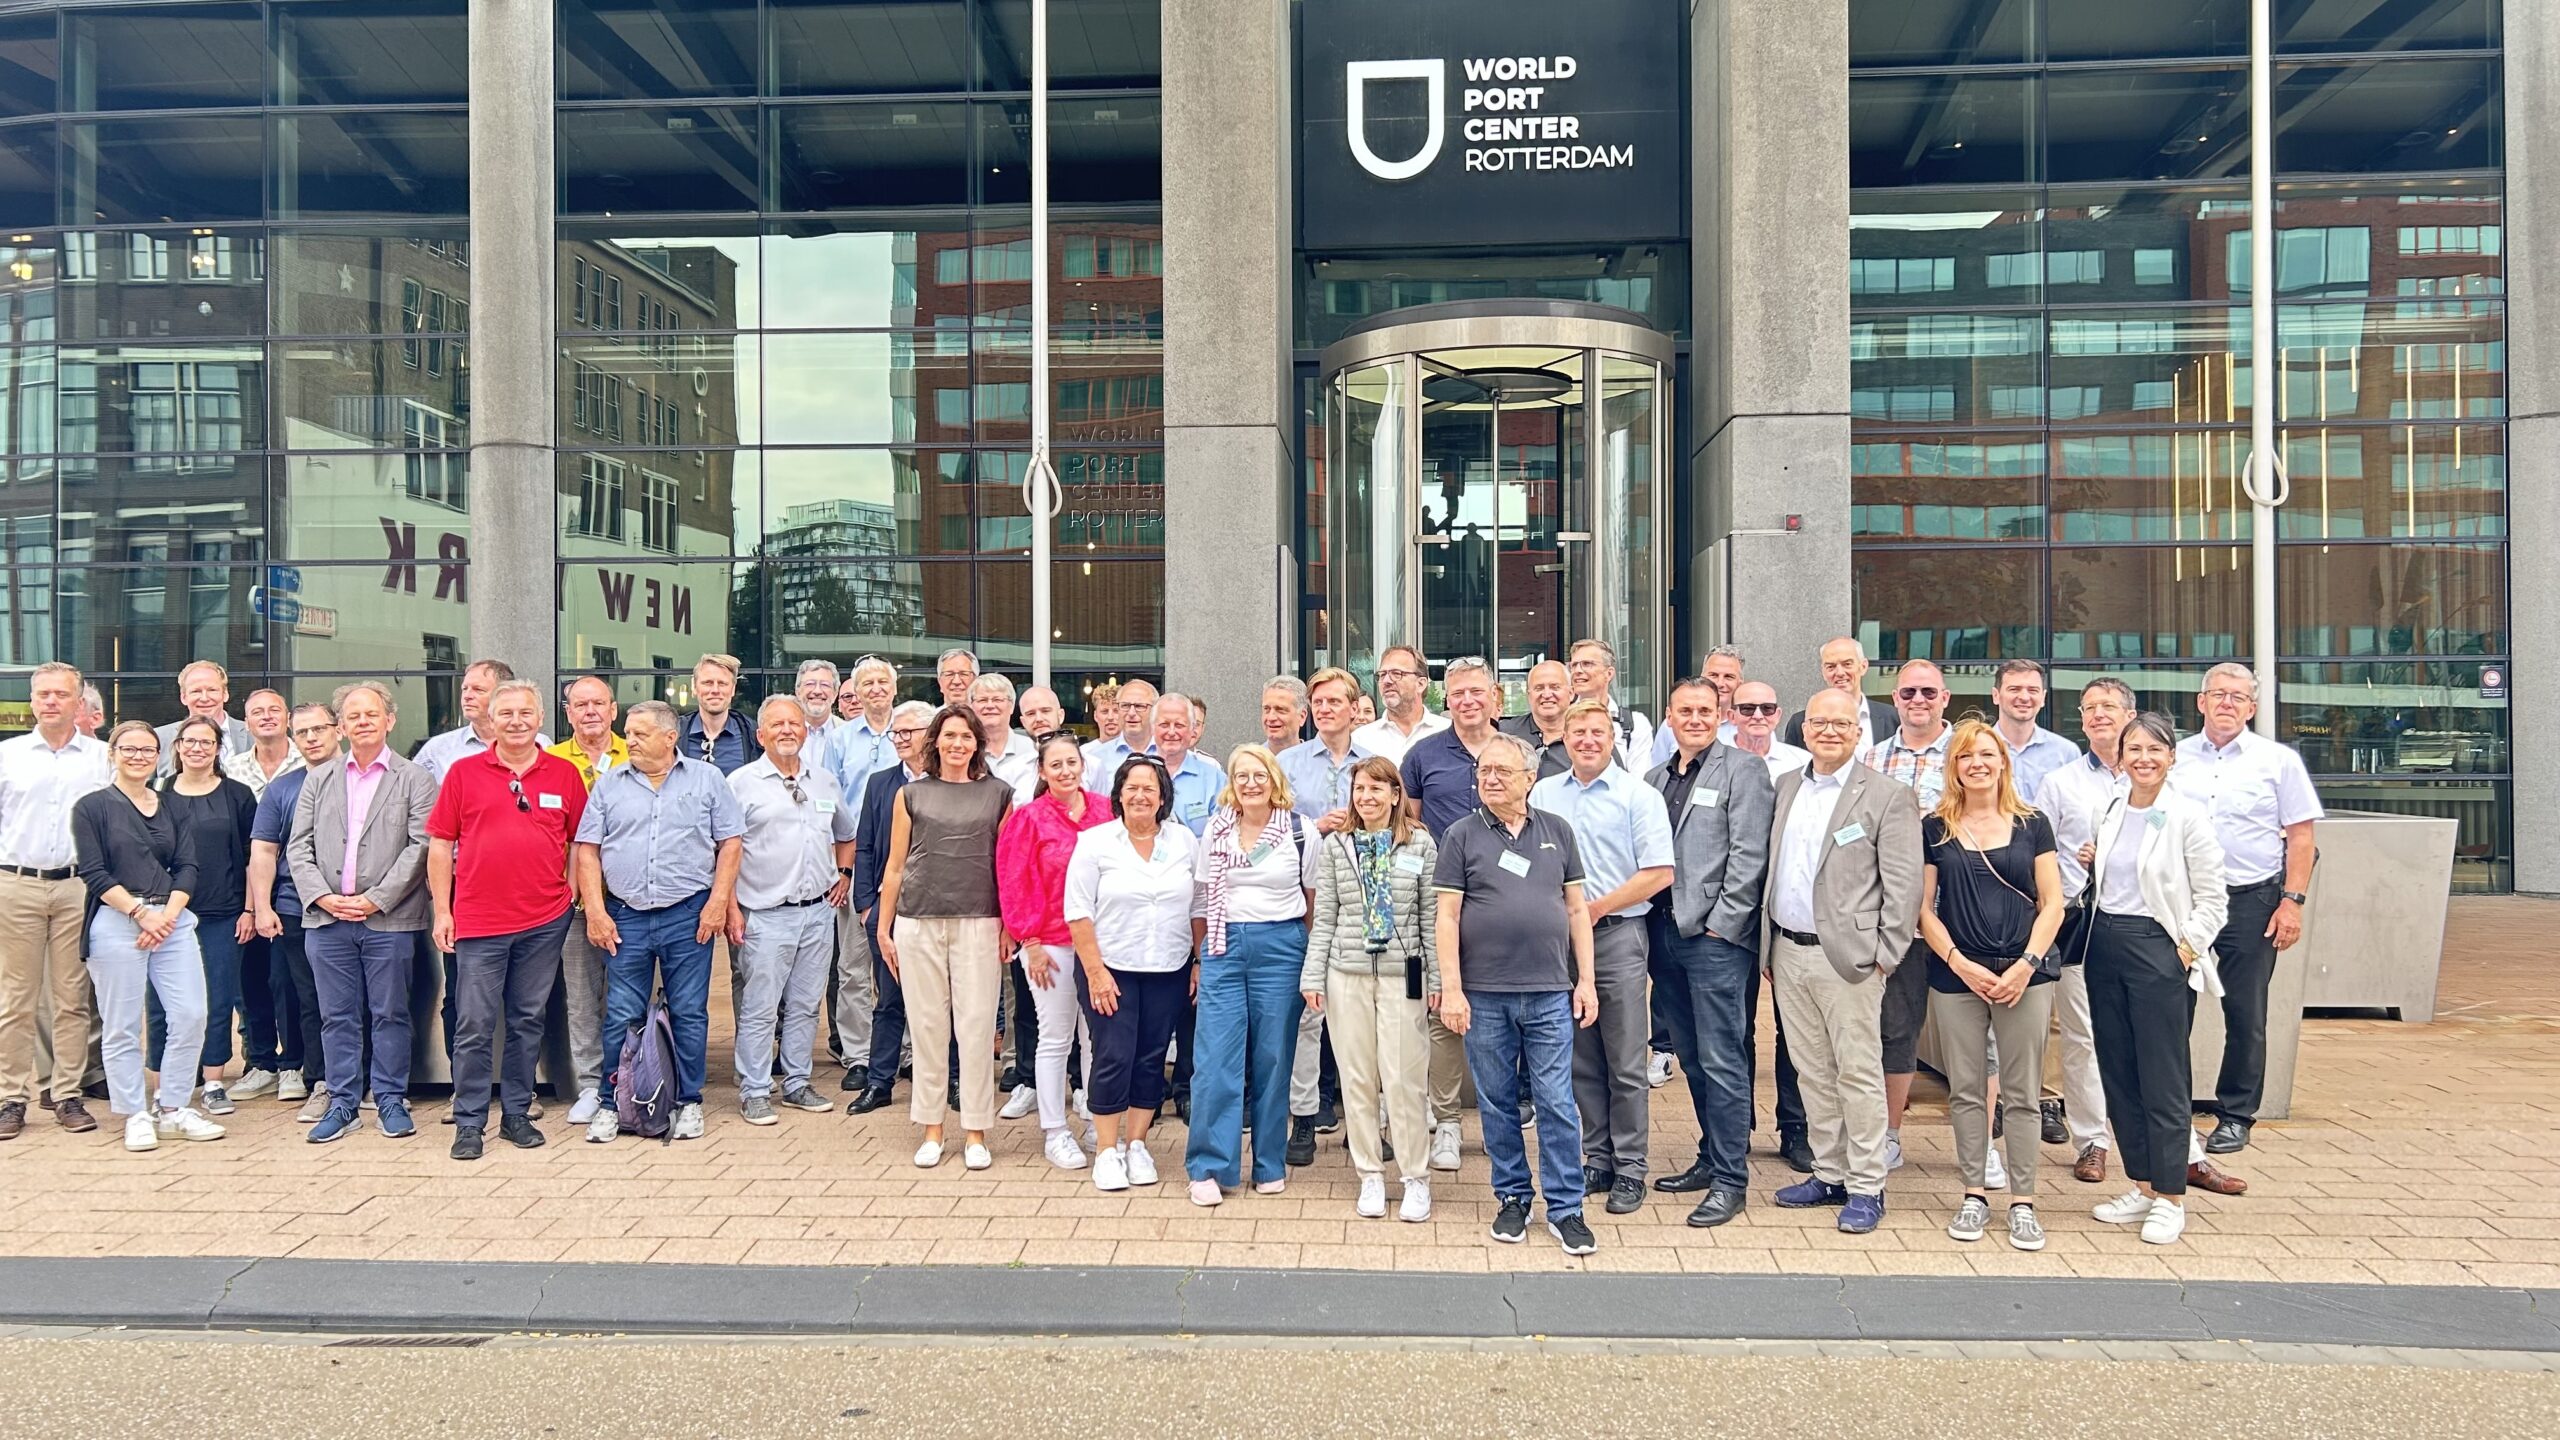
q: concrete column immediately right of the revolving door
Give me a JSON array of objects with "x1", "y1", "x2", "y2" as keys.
[{"x1": 1679, "y1": 0, "x2": 1851, "y2": 710}]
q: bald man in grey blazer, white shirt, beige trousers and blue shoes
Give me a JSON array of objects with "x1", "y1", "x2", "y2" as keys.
[{"x1": 1761, "y1": 689, "x2": 1920, "y2": 1219}]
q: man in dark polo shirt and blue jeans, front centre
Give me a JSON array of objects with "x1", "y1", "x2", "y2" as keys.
[{"x1": 1434, "y1": 735, "x2": 1600, "y2": 1256}]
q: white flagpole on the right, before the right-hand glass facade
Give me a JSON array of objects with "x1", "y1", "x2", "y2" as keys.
[{"x1": 2248, "y1": 0, "x2": 2291, "y2": 738}]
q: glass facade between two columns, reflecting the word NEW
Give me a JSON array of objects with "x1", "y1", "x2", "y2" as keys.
[{"x1": 553, "y1": 0, "x2": 1165, "y2": 717}]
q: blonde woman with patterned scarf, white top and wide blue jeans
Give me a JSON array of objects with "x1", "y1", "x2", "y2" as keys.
[{"x1": 1185, "y1": 746, "x2": 1316, "y2": 1204}]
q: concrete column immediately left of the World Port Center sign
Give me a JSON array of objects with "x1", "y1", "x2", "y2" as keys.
[{"x1": 1165, "y1": 0, "x2": 1298, "y2": 758}]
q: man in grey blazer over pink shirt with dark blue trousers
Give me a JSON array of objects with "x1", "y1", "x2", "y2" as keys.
[{"x1": 284, "y1": 679, "x2": 435, "y2": 1145}]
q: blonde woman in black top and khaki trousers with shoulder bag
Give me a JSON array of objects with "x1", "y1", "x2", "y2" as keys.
[{"x1": 1920, "y1": 720, "x2": 2063, "y2": 1250}]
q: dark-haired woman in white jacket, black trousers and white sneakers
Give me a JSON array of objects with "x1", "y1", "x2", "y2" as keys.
[{"x1": 2081, "y1": 715, "x2": 2227, "y2": 1245}]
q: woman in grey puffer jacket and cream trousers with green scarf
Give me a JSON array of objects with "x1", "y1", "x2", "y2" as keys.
[{"x1": 1298, "y1": 758, "x2": 1439, "y2": 1222}]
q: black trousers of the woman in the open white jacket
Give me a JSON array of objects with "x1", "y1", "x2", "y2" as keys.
[{"x1": 2086, "y1": 910, "x2": 2196, "y2": 1197}]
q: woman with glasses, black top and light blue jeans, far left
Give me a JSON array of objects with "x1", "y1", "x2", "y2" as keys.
[{"x1": 72, "y1": 720, "x2": 223, "y2": 1150}]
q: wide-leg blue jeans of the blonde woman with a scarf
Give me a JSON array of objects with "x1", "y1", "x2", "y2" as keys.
[{"x1": 1185, "y1": 920, "x2": 1306, "y2": 1189}]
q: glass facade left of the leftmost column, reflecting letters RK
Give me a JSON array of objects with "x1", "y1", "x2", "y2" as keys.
[{"x1": 0, "y1": 0, "x2": 471, "y2": 746}]
